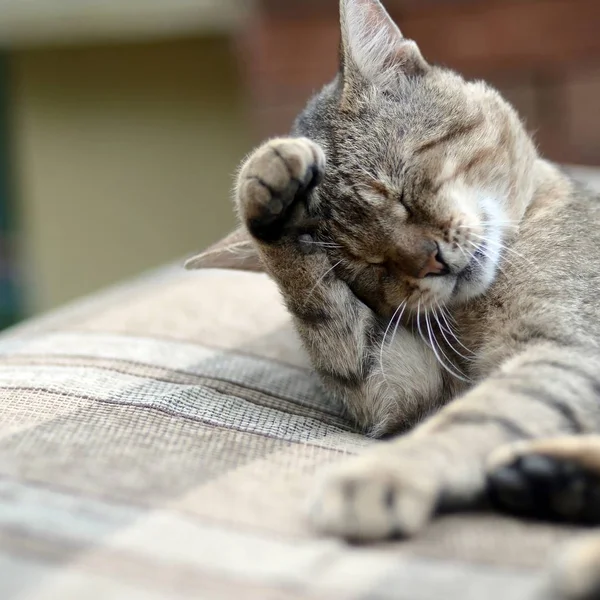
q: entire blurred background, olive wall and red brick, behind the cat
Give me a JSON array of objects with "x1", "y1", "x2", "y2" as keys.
[{"x1": 0, "y1": 0, "x2": 600, "y2": 327}]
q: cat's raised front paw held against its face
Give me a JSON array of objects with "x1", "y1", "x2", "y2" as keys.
[{"x1": 236, "y1": 138, "x2": 325, "y2": 242}]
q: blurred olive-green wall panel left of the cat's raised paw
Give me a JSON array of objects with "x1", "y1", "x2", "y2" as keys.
[{"x1": 11, "y1": 37, "x2": 250, "y2": 311}]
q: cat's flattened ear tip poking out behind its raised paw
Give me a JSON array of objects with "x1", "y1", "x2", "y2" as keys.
[{"x1": 185, "y1": 228, "x2": 265, "y2": 273}]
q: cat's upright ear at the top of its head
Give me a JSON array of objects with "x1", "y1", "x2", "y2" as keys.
[{"x1": 340, "y1": 0, "x2": 430, "y2": 87}]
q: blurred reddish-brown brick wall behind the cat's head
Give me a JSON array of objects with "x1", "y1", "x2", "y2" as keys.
[{"x1": 239, "y1": 0, "x2": 600, "y2": 165}]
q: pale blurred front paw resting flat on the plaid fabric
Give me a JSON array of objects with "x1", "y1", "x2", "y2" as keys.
[{"x1": 309, "y1": 455, "x2": 438, "y2": 541}]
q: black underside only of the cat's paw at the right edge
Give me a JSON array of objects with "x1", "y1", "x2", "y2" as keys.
[{"x1": 488, "y1": 454, "x2": 600, "y2": 524}]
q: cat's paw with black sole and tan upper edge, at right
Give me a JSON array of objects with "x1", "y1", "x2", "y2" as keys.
[{"x1": 488, "y1": 438, "x2": 600, "y2": 523}]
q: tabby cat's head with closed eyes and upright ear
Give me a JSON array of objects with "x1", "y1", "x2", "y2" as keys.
[{"x1": 294, "y1": 0, "x2": 536, "y2": 316}]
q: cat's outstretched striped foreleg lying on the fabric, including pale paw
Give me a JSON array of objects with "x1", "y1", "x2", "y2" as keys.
[{"x1": 311, "y1": 343, "x2": 600, "y2": 539}]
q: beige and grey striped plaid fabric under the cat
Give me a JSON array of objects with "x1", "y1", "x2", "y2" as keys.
[{"x1": 0, "y1": 267, "x2": 584, "y2": 600}]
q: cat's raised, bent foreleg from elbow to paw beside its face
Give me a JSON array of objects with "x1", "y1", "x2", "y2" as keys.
[{"x1": 236, "y1": 138, "x2": 441, "y2": 433}]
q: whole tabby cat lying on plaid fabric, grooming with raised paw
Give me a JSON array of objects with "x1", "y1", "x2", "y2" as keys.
[{"x1": 200, "y1": 0, "x2": 600, "y2": 599}]
